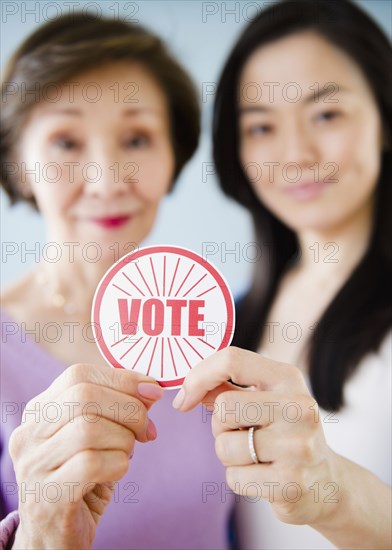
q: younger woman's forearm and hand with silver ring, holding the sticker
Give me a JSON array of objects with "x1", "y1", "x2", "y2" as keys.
[{"x1": 175, "y1": 348, "x2": 391, "y2": 550}]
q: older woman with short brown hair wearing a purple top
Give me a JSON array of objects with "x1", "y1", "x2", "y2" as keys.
[{"x1": 1, "y1": 15, "x2": 232, "y2": 549}]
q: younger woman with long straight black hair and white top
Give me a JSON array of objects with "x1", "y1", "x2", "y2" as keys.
[{"x1": 176, "y1": 0, "x2": 392, "y2": 549}]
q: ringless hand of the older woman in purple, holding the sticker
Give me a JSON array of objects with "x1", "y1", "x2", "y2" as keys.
[{"x1": 9, "y1": 364, "x2": 163, "y2": 550}]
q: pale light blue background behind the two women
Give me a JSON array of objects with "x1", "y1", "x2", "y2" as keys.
[{"x1": 0, "y1": 0, "x2": 392, "y2": 294}]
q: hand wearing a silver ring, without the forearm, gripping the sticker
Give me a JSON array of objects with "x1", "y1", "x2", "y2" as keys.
[{"x1": 174, "y1": 347, "x2": 340, "y2": 525}]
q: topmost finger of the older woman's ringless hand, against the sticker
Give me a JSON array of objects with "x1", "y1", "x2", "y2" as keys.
[{"x1": 30, "y1": 363, "x2": 164, "y2": 408}]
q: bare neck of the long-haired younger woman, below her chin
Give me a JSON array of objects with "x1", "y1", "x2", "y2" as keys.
[{"x1": 296, "y1": 199, "x2": 373, "y2": 281}]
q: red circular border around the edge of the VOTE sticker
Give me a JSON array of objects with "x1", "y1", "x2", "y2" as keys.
[{"x1": 92, "y1": 246, "x2": 235, "y2": 388}]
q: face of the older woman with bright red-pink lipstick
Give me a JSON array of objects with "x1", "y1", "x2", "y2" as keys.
[{"x1": 18, "y1": 63, "x2": 175, "y2": 257}]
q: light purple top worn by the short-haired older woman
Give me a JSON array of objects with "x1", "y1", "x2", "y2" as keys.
[{"x1": 0, "y1": 310, "x2": 234, "y2": 550}]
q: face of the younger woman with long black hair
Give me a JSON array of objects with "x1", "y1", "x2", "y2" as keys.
[{"x1": 239, "y1": 32, "x2": 382, "y2": 231}]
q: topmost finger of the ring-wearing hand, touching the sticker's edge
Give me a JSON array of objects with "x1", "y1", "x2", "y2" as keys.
[{"x1": 173, "y1": 346, "x2": 308, "y2": 411}]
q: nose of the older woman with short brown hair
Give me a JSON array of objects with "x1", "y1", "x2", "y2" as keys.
[{"x1": 83, "y1": 147, "x2": 131, "y2": 199}]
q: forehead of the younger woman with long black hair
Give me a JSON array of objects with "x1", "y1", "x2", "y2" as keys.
[{"x1": 240, "y1": 31, "x2": 369, "y2": 103}]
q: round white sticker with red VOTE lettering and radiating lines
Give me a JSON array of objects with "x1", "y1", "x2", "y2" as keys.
[{"x1": 92, "y1": 246, "x2": 235, "y2": 389}]
